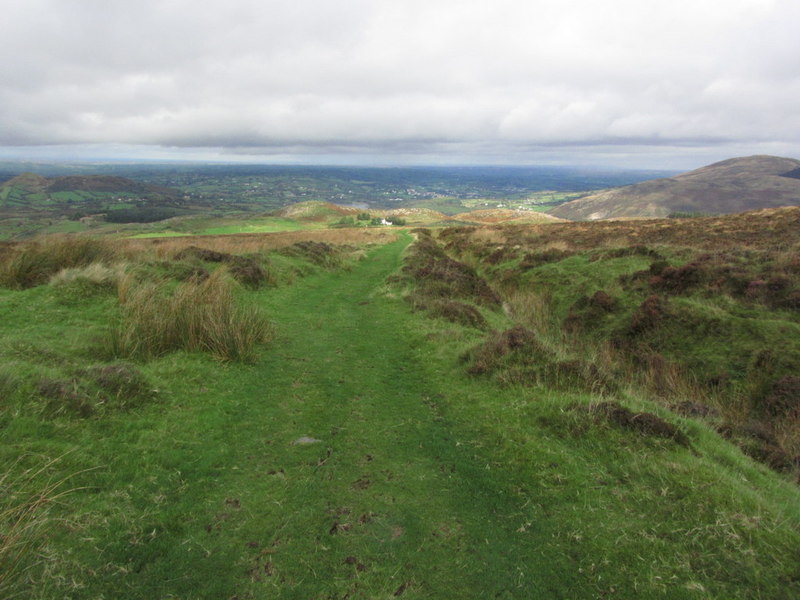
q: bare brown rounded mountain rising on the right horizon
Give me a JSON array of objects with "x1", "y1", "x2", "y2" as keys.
[{"x1": 549, "y1": 156, "x2": 800, "y2": 221}]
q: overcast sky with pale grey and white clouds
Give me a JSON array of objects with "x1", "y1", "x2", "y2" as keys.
[{"x1": 0, "y1": 0, "x2": 800, "y2": 168}]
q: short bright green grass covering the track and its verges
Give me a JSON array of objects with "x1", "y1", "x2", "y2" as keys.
[{"x1": 0, "y1": 232, "x2": 800, "y2": 599}]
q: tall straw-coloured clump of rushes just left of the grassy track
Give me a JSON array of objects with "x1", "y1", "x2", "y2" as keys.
[{"x1": 108, "y1": 269, "x2": 270, "y2": 362}]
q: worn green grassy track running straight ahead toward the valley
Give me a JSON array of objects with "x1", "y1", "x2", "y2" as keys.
[{"x1": 188, "y1": 237, "x2": 568, "y2": 598}]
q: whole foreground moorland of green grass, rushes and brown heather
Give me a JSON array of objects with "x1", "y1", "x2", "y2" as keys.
[{"x1": 0, "y1": 161, "x2": 800, "y2": 599}]
